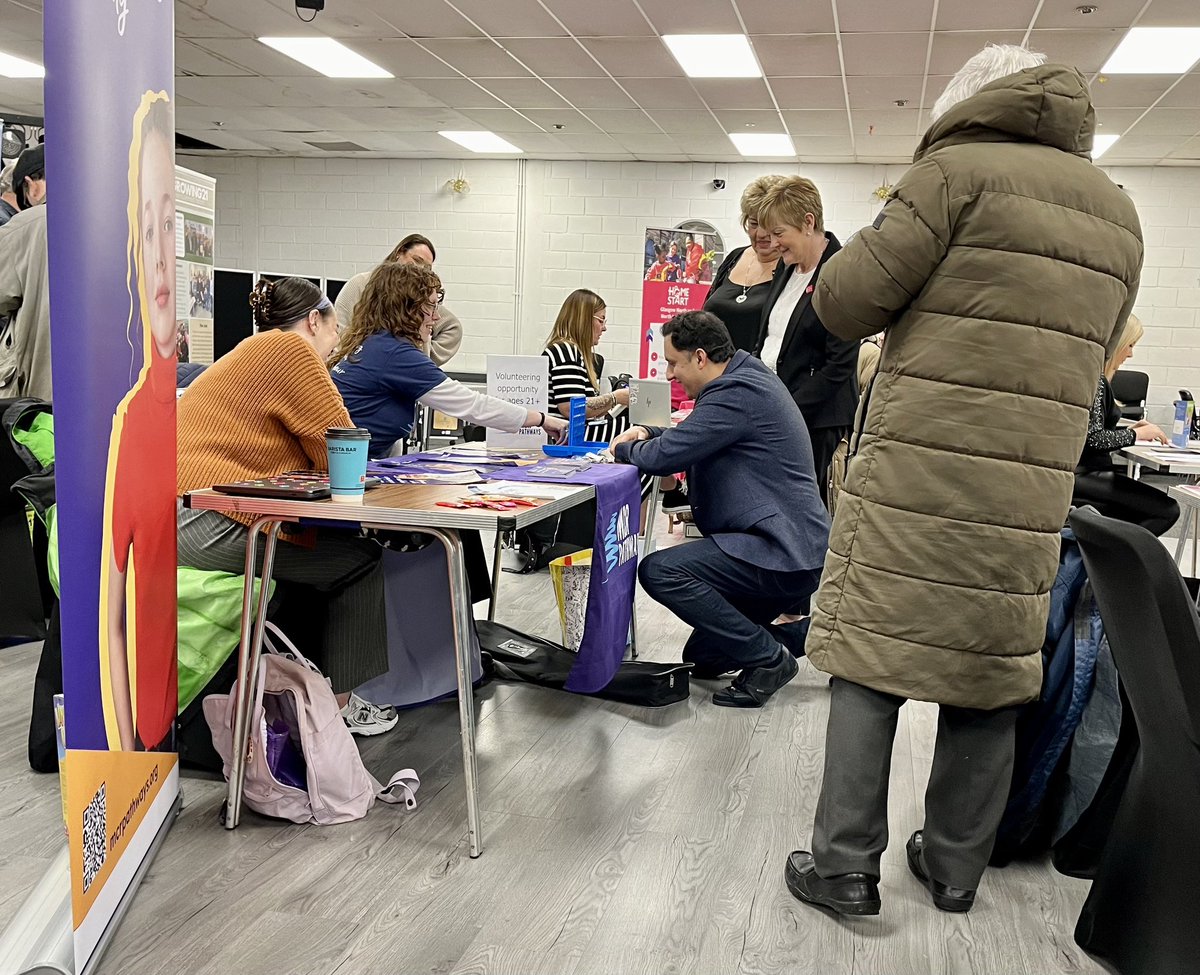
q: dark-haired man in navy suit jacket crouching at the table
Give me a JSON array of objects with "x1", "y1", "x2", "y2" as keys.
[{"x1": 611, "y1": 311, "x2": 829, "y2": 707}]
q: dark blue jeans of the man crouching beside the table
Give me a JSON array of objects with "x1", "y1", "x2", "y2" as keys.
[{"x1": 637, "y1": 538, "x2": 821, "y2": 672}]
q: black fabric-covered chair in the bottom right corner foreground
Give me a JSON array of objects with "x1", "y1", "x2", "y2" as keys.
[{"x1": 1070, "y1": 508, "x2": 1200, "y2": 975}]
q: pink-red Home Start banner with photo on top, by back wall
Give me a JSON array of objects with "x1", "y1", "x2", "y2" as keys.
[{"x1": 637, "y1": 227, "x2": 725, "y2": 396}]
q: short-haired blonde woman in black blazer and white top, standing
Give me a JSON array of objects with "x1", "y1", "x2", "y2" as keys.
[{"x1": 755, "y1": 177, "x2": 858, "y2": 501}]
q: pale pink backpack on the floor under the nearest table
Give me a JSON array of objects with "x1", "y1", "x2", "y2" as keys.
[{"x1": 204, "y1": 623, "x2": 420, "y2": 826}]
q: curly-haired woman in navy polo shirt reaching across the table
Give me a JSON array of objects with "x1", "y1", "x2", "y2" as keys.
[{"x1": 330, "y1": 263, "x2": 566, "y2": 457}]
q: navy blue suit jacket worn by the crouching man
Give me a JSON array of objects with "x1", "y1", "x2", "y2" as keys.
[{"x1": 616, "y1": 352, "x2": 829, "y2": 572}]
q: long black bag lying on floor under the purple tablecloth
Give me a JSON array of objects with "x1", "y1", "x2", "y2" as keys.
[{"x1": 475, "y1": 620, "x2": 691, "y2": 707}]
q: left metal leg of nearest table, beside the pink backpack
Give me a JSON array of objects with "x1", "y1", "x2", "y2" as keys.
[{"x1": 224, "y1": 518, "x2": 281, "y2": 830}]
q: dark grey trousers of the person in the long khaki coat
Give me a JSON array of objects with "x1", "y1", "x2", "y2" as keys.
[{"x1": 812, "y1": 677, "x2": 1016, "y2": 890}]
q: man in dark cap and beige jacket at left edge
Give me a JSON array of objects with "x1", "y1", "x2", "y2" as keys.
[{"x1": 0, "y1": 139, "x2": 53, "y2": 400}]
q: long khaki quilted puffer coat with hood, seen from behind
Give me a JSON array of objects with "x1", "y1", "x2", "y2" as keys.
[{"x1": 806, "y1": 65, "x2": 1142, "y2": 710}]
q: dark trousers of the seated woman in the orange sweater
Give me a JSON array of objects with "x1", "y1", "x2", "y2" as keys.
[{"x1": 178, "y1": 504, "x2": 388, "y2": 694}]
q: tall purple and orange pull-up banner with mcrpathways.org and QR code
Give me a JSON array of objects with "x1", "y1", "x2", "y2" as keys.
[{"x1": 43, "y1": 0, "x2": 179, "y2": 974}]
